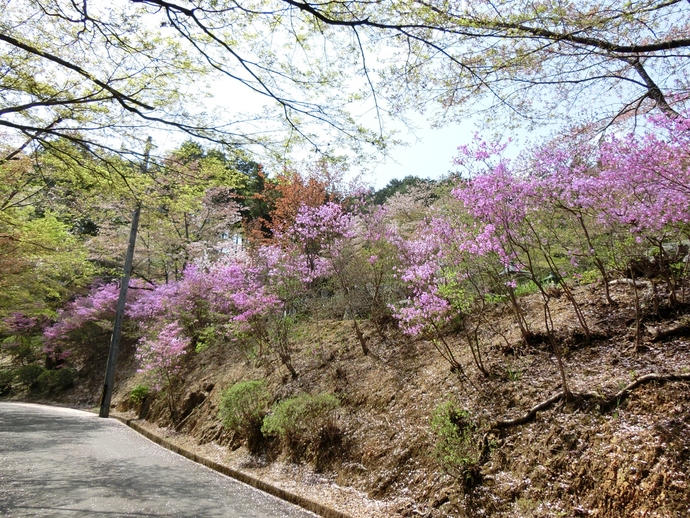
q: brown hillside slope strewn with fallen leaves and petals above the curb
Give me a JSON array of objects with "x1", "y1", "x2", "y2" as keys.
[{"x1": 16, "y1": 286, "x2": 690, "y2": 517}]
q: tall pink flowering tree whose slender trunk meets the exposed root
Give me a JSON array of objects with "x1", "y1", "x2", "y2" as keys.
[{"x1": 453, "y1": 139, "x2": 612, "y2": 399}]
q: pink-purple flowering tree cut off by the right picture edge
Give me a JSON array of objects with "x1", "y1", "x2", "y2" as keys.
[{"x1": 591, "y1": 118, "x2": 690, "y2": 305}]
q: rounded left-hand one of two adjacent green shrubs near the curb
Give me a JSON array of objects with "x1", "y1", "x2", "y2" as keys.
[{"x1": 220, "y1": 380, "x2": 271, "y2": 451}]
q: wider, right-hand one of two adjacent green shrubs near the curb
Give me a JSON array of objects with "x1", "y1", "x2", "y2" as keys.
[{"x1": 261, "y1": 393, "x2": 342, "y2": 468}]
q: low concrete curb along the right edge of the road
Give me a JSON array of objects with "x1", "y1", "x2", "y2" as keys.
[{"x1": 110, "y1": 415, "x2": 352, "y2": 518}]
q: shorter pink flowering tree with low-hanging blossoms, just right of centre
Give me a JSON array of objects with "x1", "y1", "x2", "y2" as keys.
[{"x1": 394, "y1": 205, "x2": 512, "y2": 376}]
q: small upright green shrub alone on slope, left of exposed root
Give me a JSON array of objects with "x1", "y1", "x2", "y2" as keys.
[{"x1": 431, "y1": 401, "x2": 481, "y2": 486}]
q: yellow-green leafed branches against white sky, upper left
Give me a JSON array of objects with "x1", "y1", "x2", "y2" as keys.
[{"x1": 0, "y1": 0, "x2": 383, "y2": 167}]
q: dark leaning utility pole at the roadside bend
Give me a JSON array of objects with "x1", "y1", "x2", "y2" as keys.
[{"x1": 98, "y1": 137, "x2": 153, "y2": 417}]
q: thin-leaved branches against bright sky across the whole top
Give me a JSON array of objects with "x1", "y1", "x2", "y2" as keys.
[{"x1": 0, "y1": 0, "x2": 690, "y2": 168}]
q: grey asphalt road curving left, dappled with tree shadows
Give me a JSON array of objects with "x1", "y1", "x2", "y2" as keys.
[{"x1": 0, "y1": 403, "x2": 316, "y2": 518}]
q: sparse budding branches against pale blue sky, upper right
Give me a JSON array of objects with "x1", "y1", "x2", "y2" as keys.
[{"x1": 276, "y1": 0, "x2": 690, "y2": 129}]
